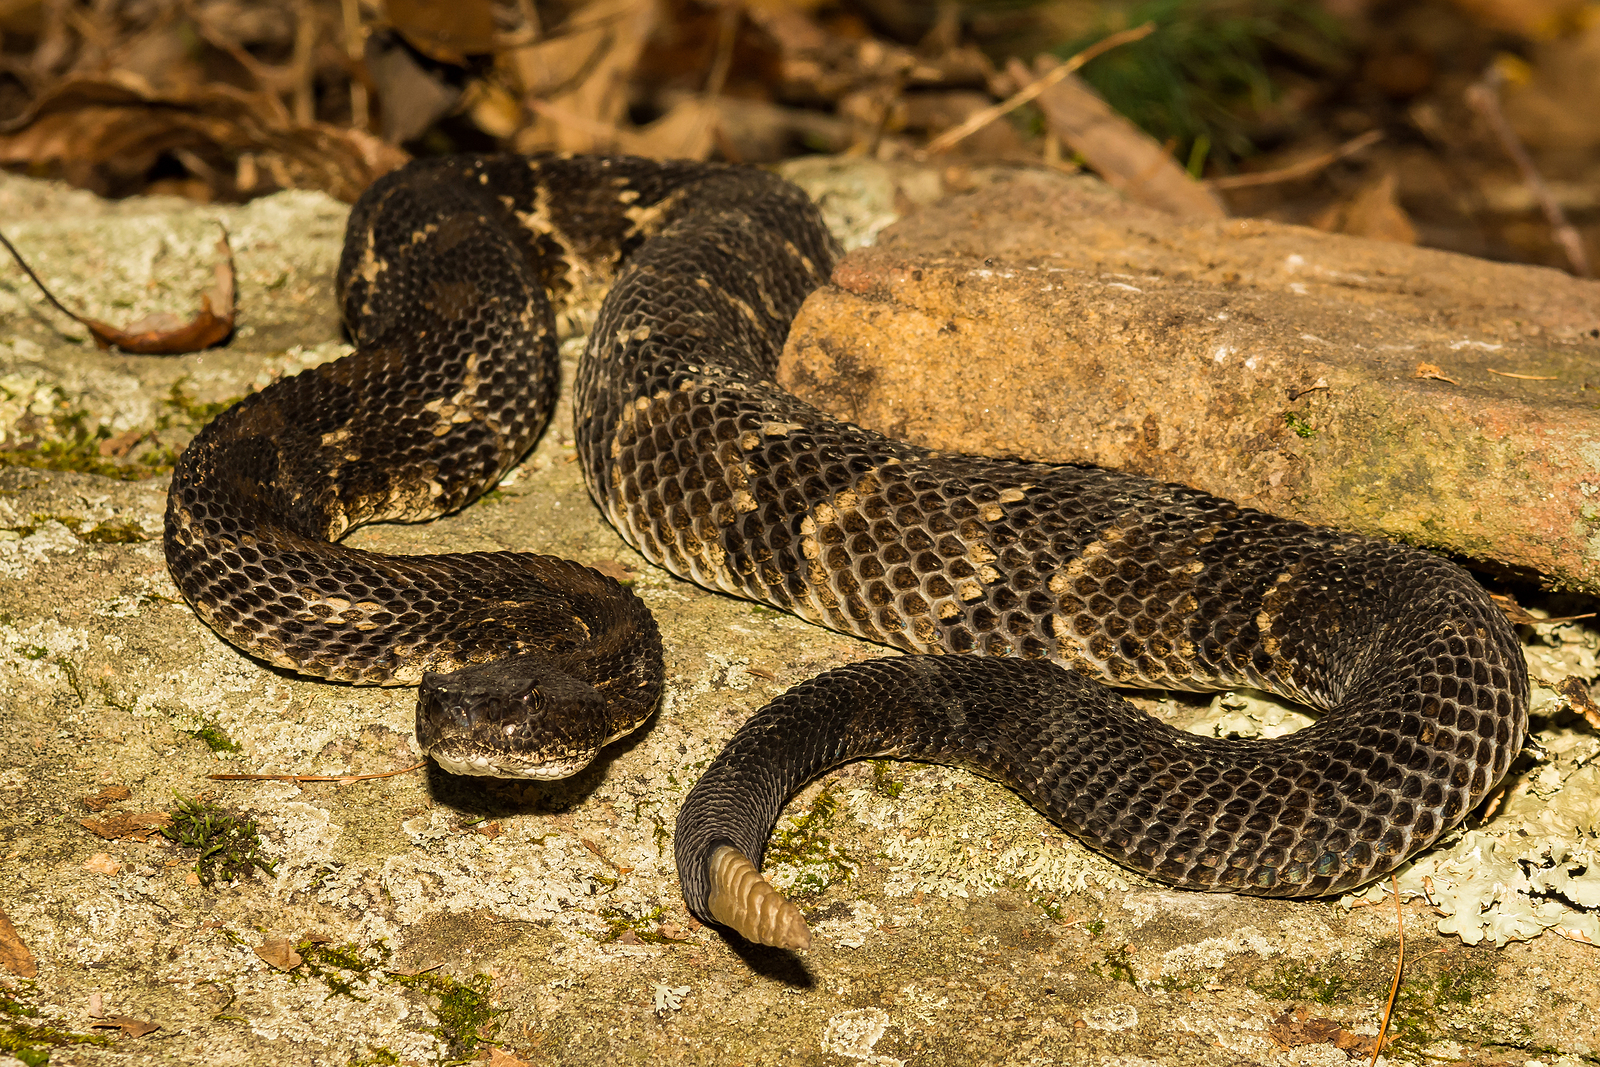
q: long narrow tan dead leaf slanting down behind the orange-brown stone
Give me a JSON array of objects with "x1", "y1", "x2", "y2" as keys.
[{"x1": 1006, "y1": 58, "x2": 1227, "y2": 219}]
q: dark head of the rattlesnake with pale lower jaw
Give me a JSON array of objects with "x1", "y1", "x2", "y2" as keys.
[{"x1": 416, "y1": 656, "x2": 611, "y2": 781}]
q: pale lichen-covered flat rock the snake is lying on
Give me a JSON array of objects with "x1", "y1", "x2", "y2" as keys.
[{"x1": 0, "y1": 167, "x2": 1600, "y2": 1067}]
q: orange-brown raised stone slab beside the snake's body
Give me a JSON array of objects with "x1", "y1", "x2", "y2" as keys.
[{"x1": 781, "y1": 181, "x2": 1600, "y2": 592}]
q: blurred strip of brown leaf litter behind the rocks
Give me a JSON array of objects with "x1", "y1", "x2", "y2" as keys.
[{"x1": 0, "y1": 0, "x2": 1600, "y2": 272}]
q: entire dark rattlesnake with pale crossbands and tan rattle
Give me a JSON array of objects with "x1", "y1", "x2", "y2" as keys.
[{"x1": 166, "y1": 157, "x2": 1528, "y2": 947}]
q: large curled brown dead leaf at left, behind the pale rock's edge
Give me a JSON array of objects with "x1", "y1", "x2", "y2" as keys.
[{"x1": 0, "y1": 77, "x2": 408, "y2": 202}]
